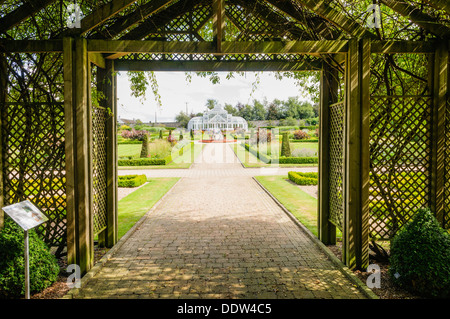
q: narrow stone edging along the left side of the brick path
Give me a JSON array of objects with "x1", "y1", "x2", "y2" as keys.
[{"x1": 61, "y1": 178, "x2": 182, "y2": 299}]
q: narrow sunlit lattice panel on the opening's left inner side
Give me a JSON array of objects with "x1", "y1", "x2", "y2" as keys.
[{"x1": 92, "y1": 106, "x2": 108, "y2": 234}]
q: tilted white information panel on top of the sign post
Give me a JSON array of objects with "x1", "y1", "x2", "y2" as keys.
[{"x1": 2, "y1": 200, "x2": 48, "y2": 230}]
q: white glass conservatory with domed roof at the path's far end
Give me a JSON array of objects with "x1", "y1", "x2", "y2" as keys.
[{"x1": 188, "y1": 105, "x2": 248, "y2": 131}]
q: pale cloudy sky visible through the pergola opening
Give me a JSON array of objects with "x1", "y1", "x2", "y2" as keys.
[{"x1": 117, "y1": 72, "x2": 312, "y2": 122}]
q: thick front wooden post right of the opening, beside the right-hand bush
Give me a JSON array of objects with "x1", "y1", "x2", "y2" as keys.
[{"x1": 342, "y1": 39, "x2": 370, "y2": 269}]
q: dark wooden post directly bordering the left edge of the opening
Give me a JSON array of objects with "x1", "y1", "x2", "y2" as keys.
[{"x1": 97, "y1": 60, "x2": 118, "y2": 247}]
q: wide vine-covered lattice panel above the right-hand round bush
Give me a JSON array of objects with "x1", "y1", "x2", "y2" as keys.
[{"x1": 369, "y1": 96, "x2": 432, "y2": 240}]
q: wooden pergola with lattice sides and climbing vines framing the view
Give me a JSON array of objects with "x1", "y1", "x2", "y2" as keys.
[{"x1": 0, "y1": 0, "x2": 450, "y2": 273}]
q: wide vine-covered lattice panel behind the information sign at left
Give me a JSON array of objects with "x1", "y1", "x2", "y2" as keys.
[{"x1": 2, "y1": 103, "x2": 66, "y2": 250}]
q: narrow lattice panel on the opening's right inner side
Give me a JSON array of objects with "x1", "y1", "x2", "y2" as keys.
[{"x1": 329, "y1": 102, "x2": 344, "y2": 230}]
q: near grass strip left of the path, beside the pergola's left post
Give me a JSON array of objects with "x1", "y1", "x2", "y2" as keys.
[{"x1": 118, "y1": 177, "x2": 179, "y2": 239}]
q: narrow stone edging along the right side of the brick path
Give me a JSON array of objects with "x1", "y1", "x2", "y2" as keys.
[{"x1": 252, "y1": 177, "x2": 379, "y2": 299}]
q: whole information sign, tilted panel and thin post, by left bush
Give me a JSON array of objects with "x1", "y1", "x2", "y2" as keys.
[{"x1": 2, "y1": 200, "x2": 48, "y2": 299}]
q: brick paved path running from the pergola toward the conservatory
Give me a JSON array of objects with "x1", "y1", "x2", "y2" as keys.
[{"x1": 70, "y1": 144, "x2": 364, "y2": 298}]
